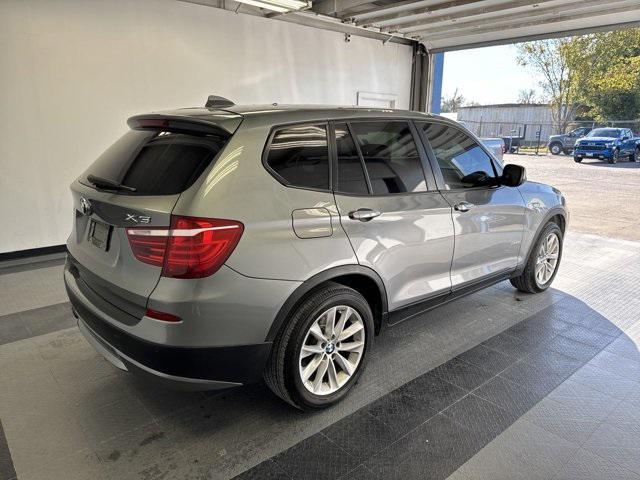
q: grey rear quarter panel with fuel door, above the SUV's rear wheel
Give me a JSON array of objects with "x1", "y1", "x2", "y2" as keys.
[{"x1": 174, "y1": 116, "x2": 358, "y2": 281}]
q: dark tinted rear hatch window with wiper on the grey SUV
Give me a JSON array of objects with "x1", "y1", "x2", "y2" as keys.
[{"x1": 81, "y1": 130, "x2": 229, "y2": 195}]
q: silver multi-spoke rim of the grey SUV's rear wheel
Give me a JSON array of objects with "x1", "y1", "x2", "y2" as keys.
[{"x1": 298, "y1": 305, "x2": 365, "y2": 395}]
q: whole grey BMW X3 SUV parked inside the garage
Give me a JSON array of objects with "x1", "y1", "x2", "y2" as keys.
[{"x1": 64, "y1": 97, "x2": 567, "y2": 409}]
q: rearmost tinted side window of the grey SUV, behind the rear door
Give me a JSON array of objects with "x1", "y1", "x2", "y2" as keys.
[{"x1": 267, "y1": 125, "x2": 329, "y2": 190}]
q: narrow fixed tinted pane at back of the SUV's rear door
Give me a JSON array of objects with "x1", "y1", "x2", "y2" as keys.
[{"x1": 335, "y1": 123, "x2": 369, "y2": 194}]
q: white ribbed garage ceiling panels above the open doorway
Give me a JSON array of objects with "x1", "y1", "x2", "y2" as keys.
[{"x1": 182, "y1": 0, "x2": 640, "y2": 51}]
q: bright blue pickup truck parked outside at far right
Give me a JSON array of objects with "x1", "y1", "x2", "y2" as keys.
[{"x1": 573, "y1": 128, "x2": 640, "y2": 163}]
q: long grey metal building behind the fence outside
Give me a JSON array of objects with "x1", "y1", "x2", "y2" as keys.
[{"x1": 458, "y1": 103, "x2": 556, "y2": 142}]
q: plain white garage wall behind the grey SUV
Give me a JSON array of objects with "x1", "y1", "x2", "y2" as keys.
[{"x1": 0, "y1": 0, "x2": 411, "y2": 253}]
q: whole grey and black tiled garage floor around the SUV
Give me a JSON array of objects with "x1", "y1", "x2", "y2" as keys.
[{"x1": 0, "y1": 233, "x2": 640, "y2": 480}]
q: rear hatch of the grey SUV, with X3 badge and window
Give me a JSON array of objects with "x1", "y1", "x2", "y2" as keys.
[{"x1": 67, "y1": 110, "x2": 241, "y2": 321}]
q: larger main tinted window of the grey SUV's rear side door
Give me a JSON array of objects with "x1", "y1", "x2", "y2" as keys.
[{"x1": 351, "y1": 122, "x2": 427, "y2": 195}]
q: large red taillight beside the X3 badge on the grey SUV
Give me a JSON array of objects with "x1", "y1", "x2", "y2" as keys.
[{"x1": 127, "y1": 216, "x2": 244, "y2": 278}]
